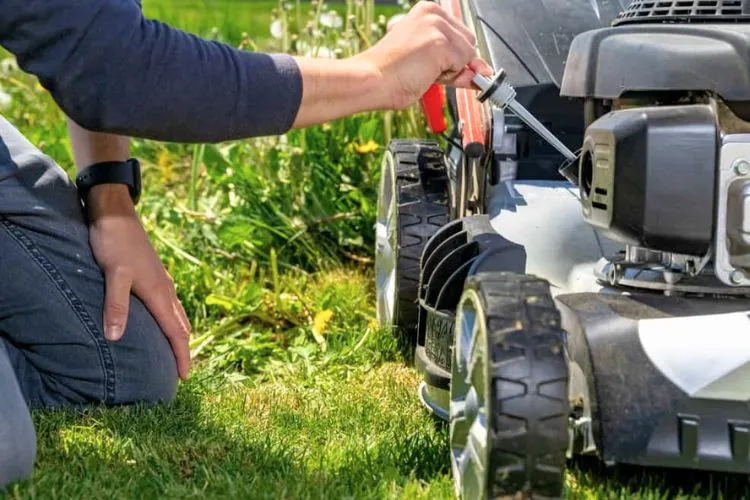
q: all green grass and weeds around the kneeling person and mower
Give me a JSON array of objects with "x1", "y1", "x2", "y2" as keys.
[{"x1": 0, "y1": 0, "x2": 749, "y2": 499}]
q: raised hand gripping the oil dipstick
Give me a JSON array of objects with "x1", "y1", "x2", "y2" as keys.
[{"x1": 357, "y1": 1, "x2": 492, "y2": 109}]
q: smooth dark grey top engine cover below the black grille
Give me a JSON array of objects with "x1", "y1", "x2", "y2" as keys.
[{"x1": 561, "y1": 24, "x2": 750, "y2": 119}]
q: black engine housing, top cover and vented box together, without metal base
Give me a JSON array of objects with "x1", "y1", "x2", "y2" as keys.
[{"x1": 560, "y1": 0, "x2": 750, "y2": 255}]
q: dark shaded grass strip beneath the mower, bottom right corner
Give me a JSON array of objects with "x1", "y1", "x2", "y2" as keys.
[{"x1": 571, "y1": 457, "x2": 750, "y2": 499}]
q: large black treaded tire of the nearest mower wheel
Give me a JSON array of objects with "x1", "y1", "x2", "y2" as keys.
[{"x1": 451, "y1": 272, "x2": 569, "y2": 498}]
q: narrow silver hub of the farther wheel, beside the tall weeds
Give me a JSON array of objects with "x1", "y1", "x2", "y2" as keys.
[{"x1": 375, "y1": 153, "x2": 398, "y2": 327}]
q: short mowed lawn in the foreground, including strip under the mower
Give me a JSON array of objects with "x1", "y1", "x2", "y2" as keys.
[{"x1": 8, "y1": 269, "x2": 750, "y2": 500}]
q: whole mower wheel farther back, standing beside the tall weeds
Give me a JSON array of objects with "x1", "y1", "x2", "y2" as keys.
[{"x1": 375, "y1": 140, "x2": 448, "y2": 347}]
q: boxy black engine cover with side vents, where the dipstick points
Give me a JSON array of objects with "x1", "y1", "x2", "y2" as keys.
[{"x1": 578, "y1": 105, "x2": 718, "y2": 255}]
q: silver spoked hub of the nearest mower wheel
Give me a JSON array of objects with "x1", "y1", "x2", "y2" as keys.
[{"x1": 450, "y1": 292, "x2": 490, "y2": 498}]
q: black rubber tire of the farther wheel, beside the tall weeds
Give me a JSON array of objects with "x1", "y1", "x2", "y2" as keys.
[{"x1": 376, "y1": 140, "x2": 448, "y2": 347}]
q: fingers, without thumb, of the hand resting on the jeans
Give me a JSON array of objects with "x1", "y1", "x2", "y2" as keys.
[{"x1": 139, "y1": 275, "x2": 190, "y2": 380}]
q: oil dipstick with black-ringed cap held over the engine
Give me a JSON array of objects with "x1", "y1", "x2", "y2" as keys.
[{"x1": 472, "y1": 69, "x2": 577, "y2": 162}]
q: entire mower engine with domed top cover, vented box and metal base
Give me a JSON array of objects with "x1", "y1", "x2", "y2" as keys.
[{"x1": 561, "y1": 0, "x2": 750, "y2": 296}]
